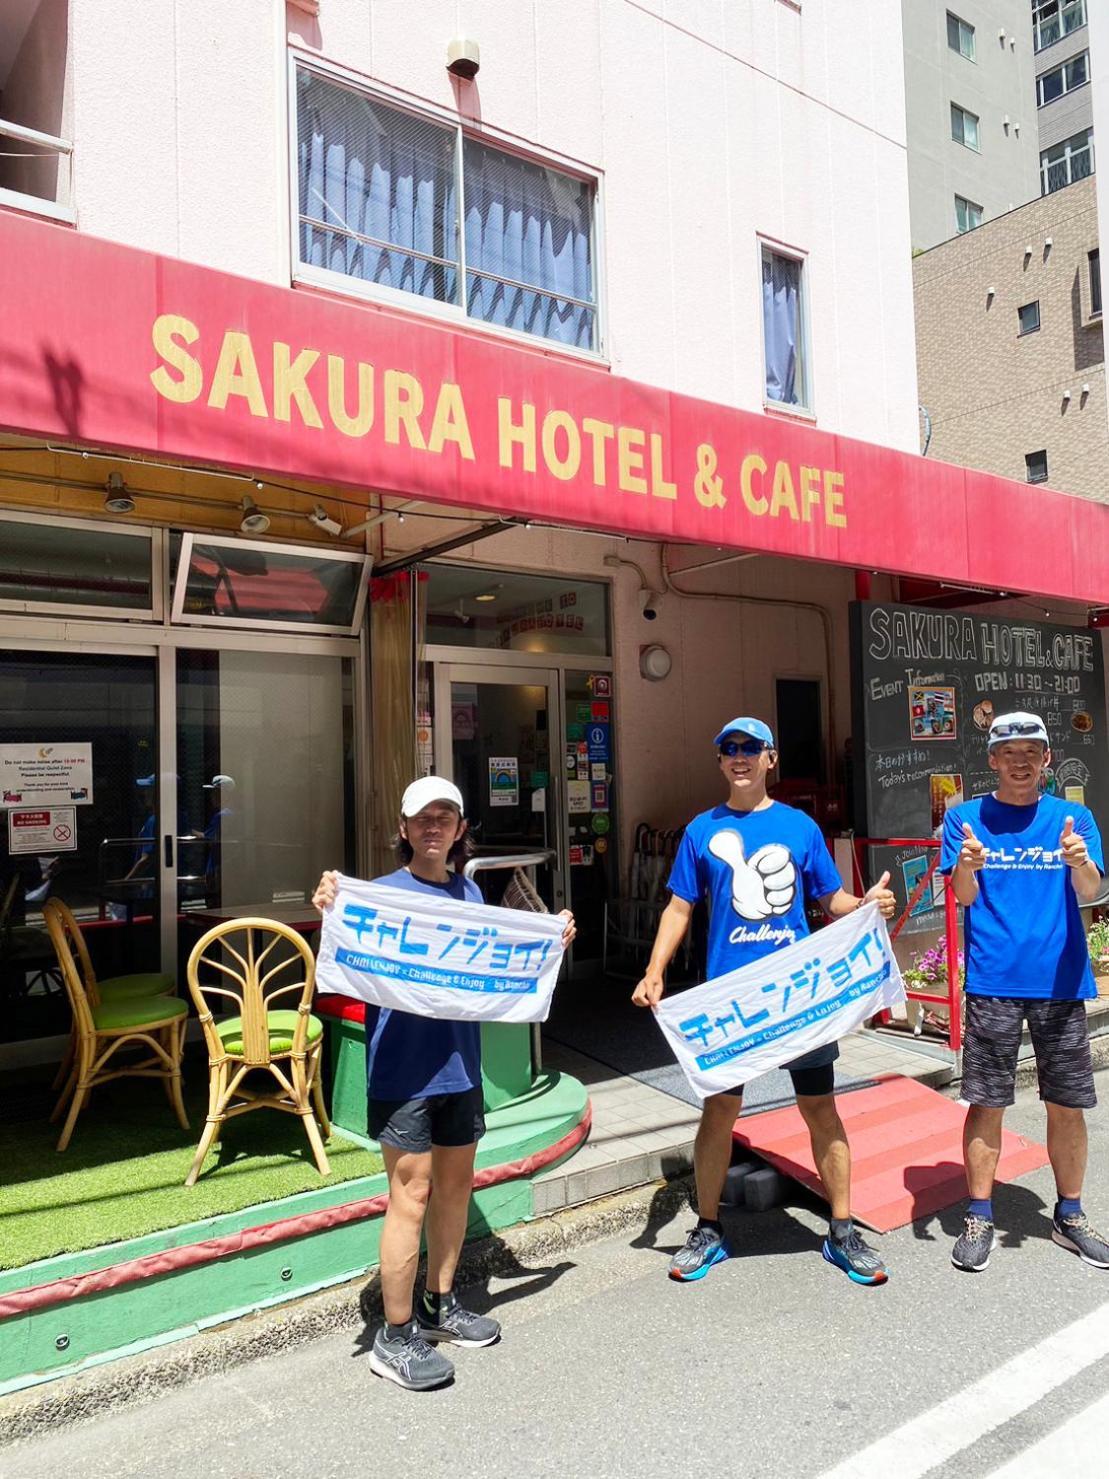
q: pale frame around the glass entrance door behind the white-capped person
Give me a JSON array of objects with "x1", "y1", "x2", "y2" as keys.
[{"x1": 429, "y1": 649, "x2": 569, "y2": 914}]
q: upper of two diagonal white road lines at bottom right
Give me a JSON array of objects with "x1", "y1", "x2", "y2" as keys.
[{"x1": 821, "y1": 1304, "x2": 1109, "y2": 1479}]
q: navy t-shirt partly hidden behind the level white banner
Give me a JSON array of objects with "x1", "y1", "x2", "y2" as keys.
[{"x1": 365, "y1": 868, "x2": 482, "y2": 1099}]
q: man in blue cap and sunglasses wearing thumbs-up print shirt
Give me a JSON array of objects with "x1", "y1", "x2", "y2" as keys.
[{"x1": 631, "y1": 719, "x2": 895, "y2": 1284}]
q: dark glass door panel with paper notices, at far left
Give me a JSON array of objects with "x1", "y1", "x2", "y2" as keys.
[{"x1": 0, "y1": 649, "x2": 163, "y2": 1057}]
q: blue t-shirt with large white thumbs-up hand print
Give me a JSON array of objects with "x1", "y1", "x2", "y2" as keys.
[{"x1": 668, "y1": 802, "x2": 841, "y2": 978}]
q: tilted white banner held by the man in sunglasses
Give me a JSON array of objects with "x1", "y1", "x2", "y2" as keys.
[{"x1": 655, "y1": 904, "x2": 905, "y2": 1099}]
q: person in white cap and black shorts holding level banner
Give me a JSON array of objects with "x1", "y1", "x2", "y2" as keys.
[{"x1": 312, "y1": 775, "x2": 575, "y2": 1392}]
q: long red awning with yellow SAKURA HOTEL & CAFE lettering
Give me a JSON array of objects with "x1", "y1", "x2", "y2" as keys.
[{"x1": 0, "y1": 211, "x2": 1109, "y2": 605}]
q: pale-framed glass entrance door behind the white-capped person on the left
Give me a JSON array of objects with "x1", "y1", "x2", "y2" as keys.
[{"x1": 435, "y1": 663, "x2": 566, "y2": 913}]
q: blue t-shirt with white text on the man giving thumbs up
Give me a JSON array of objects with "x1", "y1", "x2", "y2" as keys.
[{"x1": 940, "y1": 796, "x2": 1105, "y2": 1001}]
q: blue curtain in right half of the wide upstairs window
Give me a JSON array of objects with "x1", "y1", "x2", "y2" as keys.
[{"x1": 463, "y1": 139, "x2": 596, "y2": 349}]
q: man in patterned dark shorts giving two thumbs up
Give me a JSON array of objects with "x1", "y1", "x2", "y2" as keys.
[{"x1": 940, "y1": 713, "x2": 1109, "y2": 1273}]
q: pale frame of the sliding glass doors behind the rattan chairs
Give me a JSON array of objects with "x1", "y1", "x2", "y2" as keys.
[{"x1": 0, "y1": 612, "x2": 370, "y2": 976}]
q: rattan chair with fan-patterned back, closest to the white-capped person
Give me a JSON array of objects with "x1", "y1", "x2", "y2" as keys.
[{"x1": 185, "y1": 918, "x2": 331, "y2": 1186}]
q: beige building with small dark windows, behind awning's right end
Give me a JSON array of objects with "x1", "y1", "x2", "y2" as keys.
[{"x1": 912, "y1": 177, "x2": 1109, "y2": 503}]
